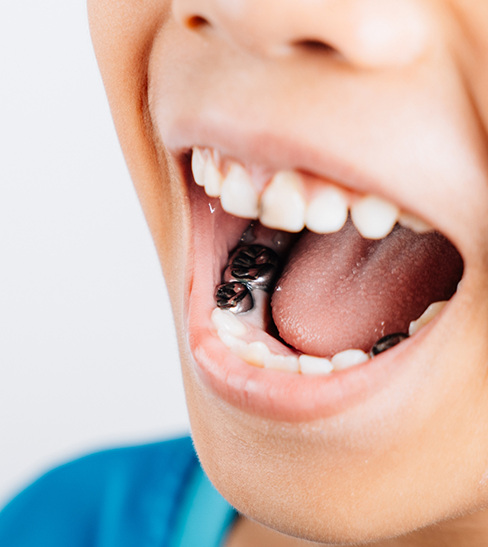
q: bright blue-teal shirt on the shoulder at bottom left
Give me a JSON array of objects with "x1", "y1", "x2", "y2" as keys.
[{"x1": 0, "y1": 437, "x2": 236, "y2": 547}]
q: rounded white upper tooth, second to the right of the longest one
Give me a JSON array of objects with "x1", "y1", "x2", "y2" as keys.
[{"x1": 351, "y1": 196, "x2": 399, "y2": 239}]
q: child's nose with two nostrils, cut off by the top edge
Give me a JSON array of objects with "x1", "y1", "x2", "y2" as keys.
[{"x1": 173, "y1": 0, "x2": 429, "y2": 69}]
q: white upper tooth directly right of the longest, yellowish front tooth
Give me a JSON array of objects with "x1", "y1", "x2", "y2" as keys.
[{"x1": 305, "y1": 186, "x2": 348, "y2": 234}]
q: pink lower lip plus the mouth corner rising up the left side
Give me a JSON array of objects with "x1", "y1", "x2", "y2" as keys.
[{"x1": 188, "y1": 177, "x2": 430, "y2": 422}]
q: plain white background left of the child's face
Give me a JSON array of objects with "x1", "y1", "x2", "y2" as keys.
[{"x1": 0, "y1": 0, "x2": 188, "y2": 504}]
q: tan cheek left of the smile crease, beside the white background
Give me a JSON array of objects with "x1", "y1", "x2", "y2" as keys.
[{"x1": 88, "y1": 0, "x2": 188, "y2": 296}]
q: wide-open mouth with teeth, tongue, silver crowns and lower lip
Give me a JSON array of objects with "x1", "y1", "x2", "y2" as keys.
[{"x1": 183, "y1": 147, "x2": 464, "y2": 421}]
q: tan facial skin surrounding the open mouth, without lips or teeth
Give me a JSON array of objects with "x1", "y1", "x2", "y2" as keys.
[{"x1": 89, "y1": 0, "x2": 488, "y2": 547}]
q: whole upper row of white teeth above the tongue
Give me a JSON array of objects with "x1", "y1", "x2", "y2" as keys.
[{"x1": 191, "y1": 147, "x2": 431, "y2": 239}]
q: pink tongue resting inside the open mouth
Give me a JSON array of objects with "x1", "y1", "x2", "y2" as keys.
[{"x1": 272, "y1": 221, "x2": 463, "y2": 357}]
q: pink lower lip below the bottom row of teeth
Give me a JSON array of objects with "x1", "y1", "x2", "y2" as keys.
[{"x1": 189, "y1": 310, "x2": 413, "y2": 422}]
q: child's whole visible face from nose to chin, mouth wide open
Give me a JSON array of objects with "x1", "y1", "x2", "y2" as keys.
[{"x1": 90, "y1": 0, "x2": 488, "y2": 542}]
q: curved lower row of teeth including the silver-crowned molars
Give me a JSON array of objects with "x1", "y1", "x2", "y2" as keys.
[{"x1": 212, "y1": 244, "x2": 446, "y2": 374}]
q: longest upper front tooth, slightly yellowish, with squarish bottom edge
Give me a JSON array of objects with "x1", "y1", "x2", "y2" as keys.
[{"x1": 259, "y1": 171, "x2": 306, "y2": 232}]
